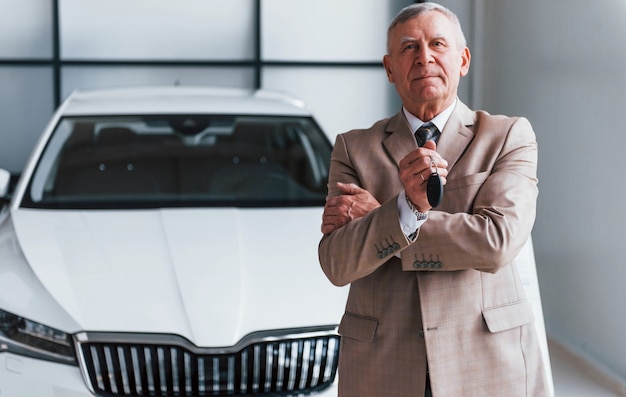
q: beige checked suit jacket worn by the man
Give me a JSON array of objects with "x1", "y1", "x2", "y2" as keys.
[{"x1": 319, "y1": 101, "x2": 549, "y2": 397}]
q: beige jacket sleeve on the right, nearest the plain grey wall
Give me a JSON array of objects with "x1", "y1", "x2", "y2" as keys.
[{"x1": 402, "y1": 116, "x2": 538, "y2": 273}]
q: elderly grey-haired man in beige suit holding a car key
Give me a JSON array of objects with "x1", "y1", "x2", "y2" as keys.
[{"x1": 319, "y1": 3, "x2": 549, "y2": 397}]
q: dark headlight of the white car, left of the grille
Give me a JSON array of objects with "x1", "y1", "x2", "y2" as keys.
[{"x1": 0, "y1": 310, "x2": 76, "y2": 365}]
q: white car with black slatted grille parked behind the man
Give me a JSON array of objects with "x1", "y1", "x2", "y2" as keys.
[{"x1": 0, "y1": 86, "x2": 347, "y2": 397}]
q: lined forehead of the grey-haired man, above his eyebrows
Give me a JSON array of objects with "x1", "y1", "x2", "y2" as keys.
[{"x1": 391, "y1": 10, "x2": 458, "y2": 43}]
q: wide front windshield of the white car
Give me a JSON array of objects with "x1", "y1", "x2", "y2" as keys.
[{"x1": 22, "y1": 115, "x2": 331, "y2": 209}]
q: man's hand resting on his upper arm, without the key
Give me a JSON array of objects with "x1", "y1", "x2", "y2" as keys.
[{"x1": 322, "y1": 182, "x2": 380, "y2": 234}]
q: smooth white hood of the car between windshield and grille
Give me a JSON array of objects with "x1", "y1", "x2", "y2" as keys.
[{"x1": 12, "y1": 208, "x2": 345, "y2": 346}]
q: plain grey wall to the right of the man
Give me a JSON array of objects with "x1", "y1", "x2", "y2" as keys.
[{"x1": 472, "y1": 0, "x2": 626, "y2": 384}]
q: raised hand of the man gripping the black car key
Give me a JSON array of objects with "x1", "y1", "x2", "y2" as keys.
[{"x1": 399, "y1": 141, "x2": 448, "y2": 212}]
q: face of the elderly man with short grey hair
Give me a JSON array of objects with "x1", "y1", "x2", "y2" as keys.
[{"x1": 383, "y1": 11, "x2": 470, "y2": 120}]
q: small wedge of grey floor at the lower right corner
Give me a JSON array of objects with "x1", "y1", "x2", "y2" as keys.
[{"x1": 549, "y1": 343, "x2": 626, "y2": 397}]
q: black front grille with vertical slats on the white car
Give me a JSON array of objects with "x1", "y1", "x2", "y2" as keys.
[{"x1": 77, "y1": 327, "x2": 339, "y2": 397}]
